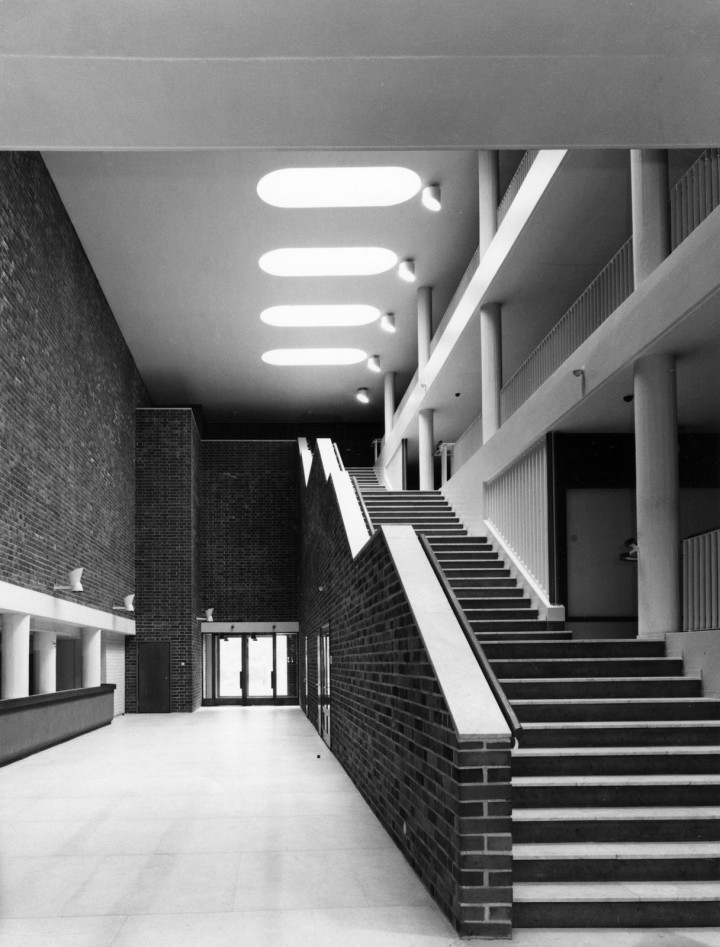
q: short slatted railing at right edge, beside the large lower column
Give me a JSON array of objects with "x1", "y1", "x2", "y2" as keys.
[{"x1": 682, "y1": 529, "x2": 720, "y2": 631}]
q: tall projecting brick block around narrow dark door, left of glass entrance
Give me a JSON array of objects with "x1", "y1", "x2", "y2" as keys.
[{"x1": 126, "y1": 408, "x2": 204, "y2": 713}]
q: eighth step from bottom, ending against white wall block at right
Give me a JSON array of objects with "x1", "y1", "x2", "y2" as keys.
[{"x1": 496, "y1": 671, "x2": 702, "y2": 701}]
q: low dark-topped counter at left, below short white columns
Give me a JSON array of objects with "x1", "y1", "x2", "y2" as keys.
[{"x1": 0, "y1": 684, "x2": 115, "y2": 766}]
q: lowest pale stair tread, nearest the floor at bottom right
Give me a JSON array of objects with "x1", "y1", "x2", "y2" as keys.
[{"x1": 513, "y1": 881, "x2": 720, "y2": 902}]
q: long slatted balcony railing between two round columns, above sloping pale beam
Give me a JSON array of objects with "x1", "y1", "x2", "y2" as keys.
[{"x1": 500, "y1": 237, "x2": 633, "y2": 424}]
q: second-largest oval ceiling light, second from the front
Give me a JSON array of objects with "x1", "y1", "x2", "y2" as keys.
[{"x1": 258, "y1": 247, "x2": 397, "y2": 276}]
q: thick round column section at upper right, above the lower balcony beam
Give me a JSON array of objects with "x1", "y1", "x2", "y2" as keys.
[{"x1": 630, "y1": 149, "x2": 670, "y2": 287}]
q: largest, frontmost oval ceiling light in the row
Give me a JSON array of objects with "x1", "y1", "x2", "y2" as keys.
[{"x1": 257, "y1": 167, "x2": 422, "y2": 207}]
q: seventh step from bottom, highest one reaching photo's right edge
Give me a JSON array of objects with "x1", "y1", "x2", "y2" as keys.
[{"x1": 513, "y1": 692, "x2": 720, "y2": 723}]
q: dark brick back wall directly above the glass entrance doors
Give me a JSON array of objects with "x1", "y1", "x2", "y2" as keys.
[{"x1": 201, "y1": 440, "x2": 299, "y2": 621}]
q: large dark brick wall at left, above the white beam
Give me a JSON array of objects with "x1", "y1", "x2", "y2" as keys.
[{"x1": 0, "y1": 152, "x2": 149, "y2": 611}]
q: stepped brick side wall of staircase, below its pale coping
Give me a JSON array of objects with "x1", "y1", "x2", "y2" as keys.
[{"x1": 300, "y1": 456, "x2": 512, "y2": 937}]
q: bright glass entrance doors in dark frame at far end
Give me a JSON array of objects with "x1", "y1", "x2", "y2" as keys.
[{"x1": 203, "y1": 632, "x2": 298, "y2": 704}]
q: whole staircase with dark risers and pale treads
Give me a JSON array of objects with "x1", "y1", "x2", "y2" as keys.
[{"x1": 349, "y1": 470, "x2": 720, "y2": 928}]
